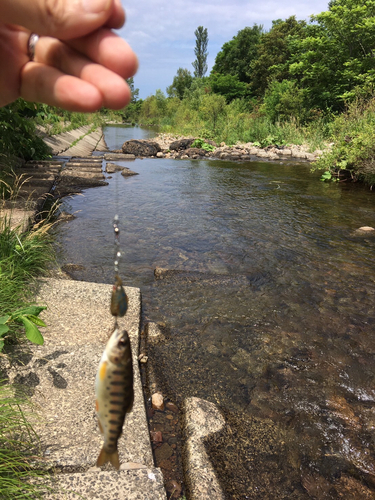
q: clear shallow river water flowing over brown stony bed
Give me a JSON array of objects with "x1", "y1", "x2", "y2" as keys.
[{"x1": 58, "y1": 127, "x2": 375, "y2": 498}]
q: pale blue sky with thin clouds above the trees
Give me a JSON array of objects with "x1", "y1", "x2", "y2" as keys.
[{"x1": 117, "y1": 0, "x2": 328, "y2": 99}]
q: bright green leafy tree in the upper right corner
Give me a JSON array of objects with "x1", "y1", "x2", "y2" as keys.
[{"x1": 289, "y1": 0, "x2": 375, "y2": 111}]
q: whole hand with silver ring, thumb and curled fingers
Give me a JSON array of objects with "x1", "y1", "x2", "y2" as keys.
[{"x1": 0, "y1": 0, "x2": 138, "y2": 112}]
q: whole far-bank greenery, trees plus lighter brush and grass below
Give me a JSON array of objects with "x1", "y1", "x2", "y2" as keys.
[{"x1": 124, "y1": 0, "x2": 375, "y2": 181}]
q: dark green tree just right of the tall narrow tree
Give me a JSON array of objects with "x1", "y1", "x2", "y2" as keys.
[{"x1": 212, "y1": 24, "x2": 263, "y2": 83}]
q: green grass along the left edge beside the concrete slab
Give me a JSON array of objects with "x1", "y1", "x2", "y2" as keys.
[{"x1": 0, "y1": 172, "x2": 54, "y2": 500}]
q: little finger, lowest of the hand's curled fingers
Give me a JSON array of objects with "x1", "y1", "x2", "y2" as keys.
[{"x1": 20, "y1": 62, "x2": 103, "y2": 112}]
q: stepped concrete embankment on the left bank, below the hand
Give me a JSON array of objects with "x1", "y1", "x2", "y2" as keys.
[{"x1": 0, "y1": 126, "x2": 134, "y2": 226}]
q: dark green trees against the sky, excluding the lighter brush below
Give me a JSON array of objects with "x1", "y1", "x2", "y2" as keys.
[{"x1": 134, "y1": 0, "x2": 375, "y2": 121}]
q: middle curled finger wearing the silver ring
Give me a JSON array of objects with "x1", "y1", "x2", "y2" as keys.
[{"x1": 34, "y1": 37, "x2": 131, "y2": 109}]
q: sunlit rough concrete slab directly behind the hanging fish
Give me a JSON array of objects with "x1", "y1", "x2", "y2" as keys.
[{"x1": 29, "y1": 280, "x2": 154, "y2": 470}]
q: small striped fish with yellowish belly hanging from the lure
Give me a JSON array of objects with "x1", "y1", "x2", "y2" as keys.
[{"x1": 95, "y1": 328, "x2": 134, "y2": 469}]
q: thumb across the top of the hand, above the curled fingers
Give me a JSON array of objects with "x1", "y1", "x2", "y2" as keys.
[{"x1": 0, "y1": 0, "x2": 118, "y2": 40}]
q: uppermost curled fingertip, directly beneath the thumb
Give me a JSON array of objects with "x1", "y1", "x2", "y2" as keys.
[{"x1": 68, "y1": 29, "x2": 138, "y2": 79}]
